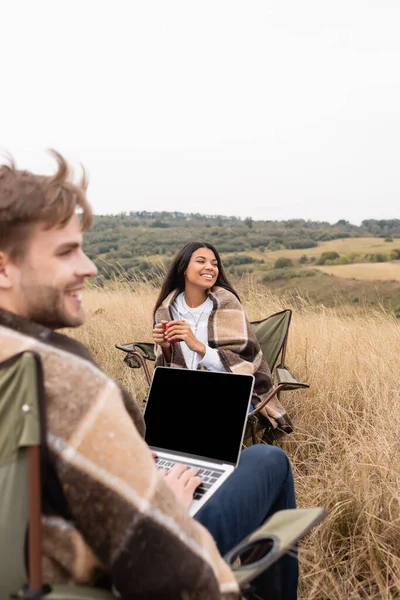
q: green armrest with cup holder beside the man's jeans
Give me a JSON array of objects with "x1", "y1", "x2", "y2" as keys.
[{"x1": 224, "y1": 507, "x2": 327, "y2": 590}]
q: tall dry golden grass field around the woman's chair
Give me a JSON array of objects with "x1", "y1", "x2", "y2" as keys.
[{"x1": 67, "y1": 282, "x2": 400, "y2": 600}]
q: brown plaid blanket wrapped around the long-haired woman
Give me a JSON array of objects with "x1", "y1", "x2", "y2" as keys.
[{"x1": 155, "y1": 286, "x2": 293, "y2": 433}]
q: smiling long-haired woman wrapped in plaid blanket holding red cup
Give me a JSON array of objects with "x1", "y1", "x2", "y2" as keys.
[{"x1": 153, "y1": 242, "x2": 282, "y2": 426}]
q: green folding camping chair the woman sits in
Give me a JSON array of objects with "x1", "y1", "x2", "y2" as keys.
[{"x1": 115, "y1": 308, "x2": 309, "y2": 444}]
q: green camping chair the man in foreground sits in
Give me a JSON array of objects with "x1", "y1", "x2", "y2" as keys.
[{"x1": 0, "y1": 351, "x2": 326, "y2": 600}]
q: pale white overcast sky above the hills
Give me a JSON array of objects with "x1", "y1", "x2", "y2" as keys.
[{"x1": 0, "y1": 0, "x2": 400, "y2": 224}]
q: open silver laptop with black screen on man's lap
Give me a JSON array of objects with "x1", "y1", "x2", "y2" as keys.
[{"x1": 144, "y1": 367, "x2": 254, "y2": 515}]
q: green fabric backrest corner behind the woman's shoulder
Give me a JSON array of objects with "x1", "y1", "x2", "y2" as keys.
[{"x1": 251, "y1": 308, "x2": 292, "y2": 372}]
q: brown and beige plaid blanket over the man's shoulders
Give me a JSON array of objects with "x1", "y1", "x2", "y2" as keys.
[{"x1": 0, "y1": 310, "x2": 240, "y2": 600}]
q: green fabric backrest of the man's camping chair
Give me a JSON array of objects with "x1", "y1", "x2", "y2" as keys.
[{"x1": 0, "y1": 352, "x2": 41, "y2": 599}]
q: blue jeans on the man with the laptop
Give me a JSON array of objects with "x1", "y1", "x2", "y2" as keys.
[{"x1": 195, "y1": 444, "x2": 298, "y2": 600}]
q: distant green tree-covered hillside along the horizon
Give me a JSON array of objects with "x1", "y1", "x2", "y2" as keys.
[{"x1": 85, "y1": 211, "x2": 400, "y2": 277}]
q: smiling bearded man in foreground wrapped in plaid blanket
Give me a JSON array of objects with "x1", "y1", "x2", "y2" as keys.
[{"x1": 0, "y1": 152, "x2": 297, "y2": 600}]
